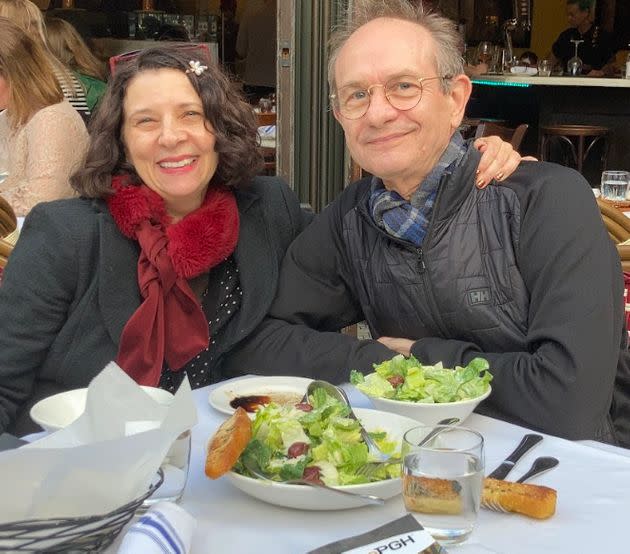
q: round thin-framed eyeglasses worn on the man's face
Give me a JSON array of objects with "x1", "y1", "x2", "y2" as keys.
[{"x1": 330, "y1": 75, "x2": 452, "y2": 119}]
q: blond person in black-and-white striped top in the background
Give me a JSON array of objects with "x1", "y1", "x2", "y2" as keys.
[{"x1": 0, "y1": 0, "x2": 92, "y2": 123}]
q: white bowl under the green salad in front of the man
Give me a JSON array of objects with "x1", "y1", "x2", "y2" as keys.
[{"x1": 368, "y1": 386, "x2": 492, "y2": 425}]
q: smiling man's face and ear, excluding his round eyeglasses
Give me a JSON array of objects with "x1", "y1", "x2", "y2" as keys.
[{"x1": 333, "y1": 18, "x2": 470, "y2": 198}]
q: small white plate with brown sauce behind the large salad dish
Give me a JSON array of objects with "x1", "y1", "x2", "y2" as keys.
[{"x1": 208, "y1": 376, "x2": 312, "y2": 415}]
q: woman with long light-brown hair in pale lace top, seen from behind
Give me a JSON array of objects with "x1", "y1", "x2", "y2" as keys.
[{"x1": 0, "y1": 17, "x2": 88, "y2": 216}]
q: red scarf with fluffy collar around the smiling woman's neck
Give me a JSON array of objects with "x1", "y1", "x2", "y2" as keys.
[{"x1": 107, "y1": 176, "x2": 239, "y2": 386}]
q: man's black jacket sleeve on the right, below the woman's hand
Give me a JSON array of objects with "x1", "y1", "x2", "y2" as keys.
[{"x1": 412, "y1": 164, "x2": 623, "y2": 439}]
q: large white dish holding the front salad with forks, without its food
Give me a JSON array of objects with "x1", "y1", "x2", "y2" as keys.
[{"x1": 227, "y1": 408, "x2": 418, "y2": 510}]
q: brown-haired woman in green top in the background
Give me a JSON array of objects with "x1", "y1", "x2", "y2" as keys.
[{"x1": 46, "y1": 17, "x2": 107, "y2": 111}]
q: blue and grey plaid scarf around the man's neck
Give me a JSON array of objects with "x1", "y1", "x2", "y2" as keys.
[{"x1": 369, "y1": 132, "x2": 467, "y2": 246}]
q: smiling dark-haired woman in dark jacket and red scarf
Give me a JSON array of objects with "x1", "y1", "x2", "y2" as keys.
[{"x1": 0, "y1": 46, "x2": 514, "y2": 434}]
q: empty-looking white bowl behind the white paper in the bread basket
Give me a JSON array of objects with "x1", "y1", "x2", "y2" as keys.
[{"x1": 30, "y1": 386, "x2": 173, "y2": 432}]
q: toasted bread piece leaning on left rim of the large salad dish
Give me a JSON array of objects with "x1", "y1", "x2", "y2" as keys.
[{"x1": 206, "y1": 408, "x2": 252, "y2": 479}]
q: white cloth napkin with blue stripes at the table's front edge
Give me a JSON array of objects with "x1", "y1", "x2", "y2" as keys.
[{"x1": 118, "y1": 502, "x2": 197, "y2": 554}]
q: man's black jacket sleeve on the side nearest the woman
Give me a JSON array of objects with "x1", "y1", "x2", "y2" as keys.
[{"x1": 223, "y1": 188, "x2": 395, "y2": 382}]
